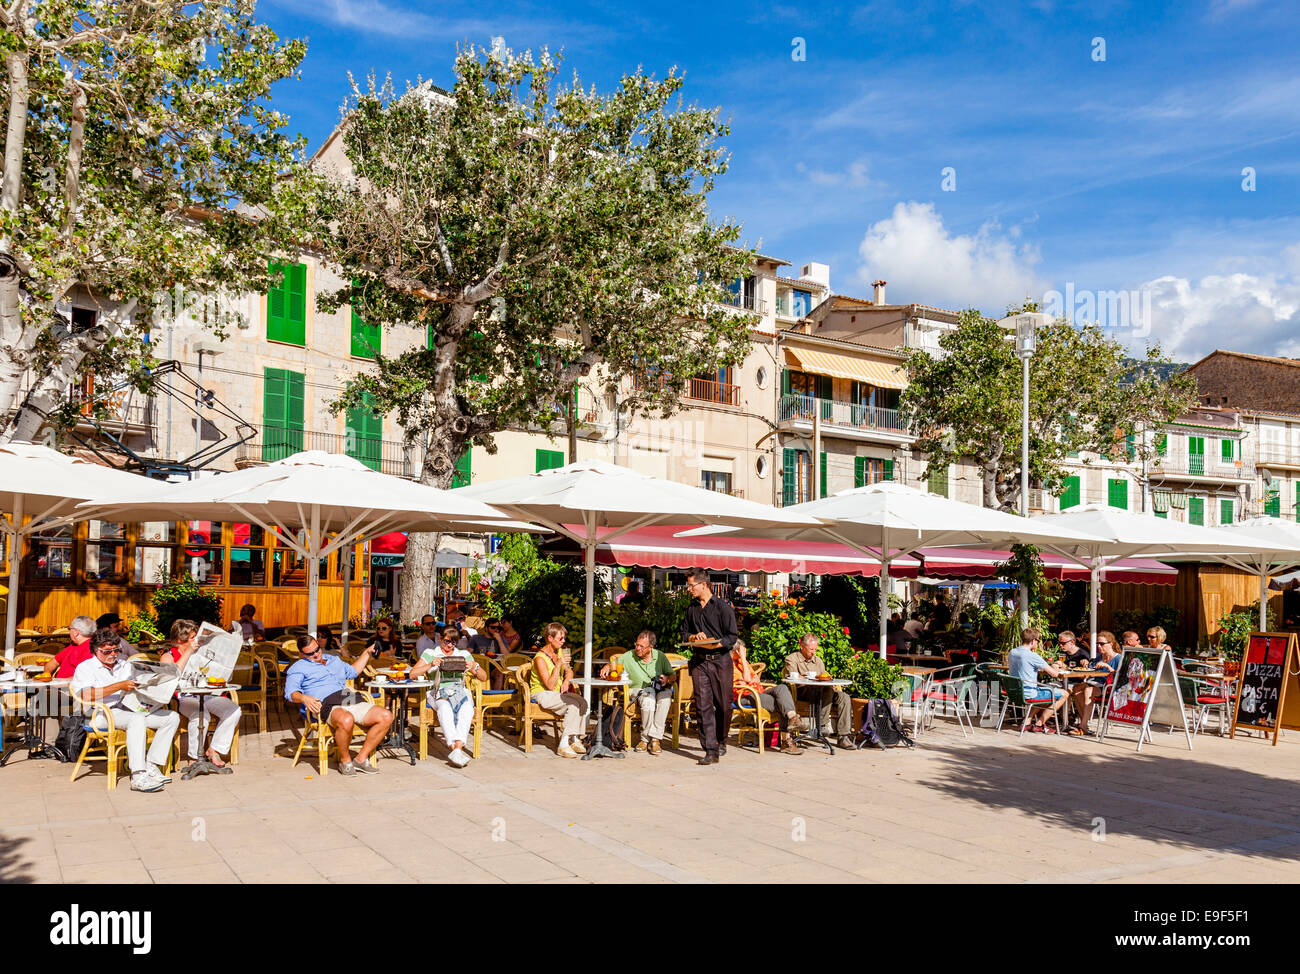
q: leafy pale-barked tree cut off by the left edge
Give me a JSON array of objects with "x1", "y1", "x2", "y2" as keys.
[{"x1": 0, "y1": 0, "x2": 306, "y2": 440}]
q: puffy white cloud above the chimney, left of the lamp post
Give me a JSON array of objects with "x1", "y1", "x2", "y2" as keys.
[{"x1": 858, "y1": 202, "x2": 1047, "y2": 315}]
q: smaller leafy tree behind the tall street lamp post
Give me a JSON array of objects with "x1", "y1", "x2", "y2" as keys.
[{"x1": 902, "y1": 306, "x2": 1196, "y2": 511}]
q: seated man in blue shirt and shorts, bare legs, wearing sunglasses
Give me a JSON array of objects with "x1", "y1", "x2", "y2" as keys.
[{"x1": 285, "y1": 636, "x2": 393, "y2": 775}]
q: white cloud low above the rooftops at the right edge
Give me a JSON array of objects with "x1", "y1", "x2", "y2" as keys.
[{"x1": 1143, "y1": 267, "x2": 1300, "y2": 362}]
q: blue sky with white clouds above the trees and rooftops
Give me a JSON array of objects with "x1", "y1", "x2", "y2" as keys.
[{"x1": 259, "y1": 0, "x2": 1300, "y2": 360}]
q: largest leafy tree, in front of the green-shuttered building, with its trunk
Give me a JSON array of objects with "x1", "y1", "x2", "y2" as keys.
[{"x1": 321, "y1": 48, "x2": 754, "y2": 616}]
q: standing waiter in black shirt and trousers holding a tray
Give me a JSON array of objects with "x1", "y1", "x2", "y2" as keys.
[{"x1": 681, "y1": 570, "x2": 740, "y2": 765}]
